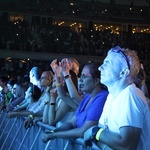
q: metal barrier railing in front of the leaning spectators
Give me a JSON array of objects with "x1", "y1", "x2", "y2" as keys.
[{"x1": 0, "y1": 112, "x2": 99, "y2": 150}]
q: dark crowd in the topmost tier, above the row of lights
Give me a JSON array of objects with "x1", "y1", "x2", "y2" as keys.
[{"x1": 0, "y1": 0, "x2": 149, "y2": 20}]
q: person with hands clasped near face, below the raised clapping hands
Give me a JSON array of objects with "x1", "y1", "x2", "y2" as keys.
[{"x1": 43, "y1": 77, "x2": 72, "y2": 126}]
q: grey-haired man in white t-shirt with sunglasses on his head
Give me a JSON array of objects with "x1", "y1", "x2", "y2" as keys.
[{"x1": 84, "y1": 46, "x2": 150, "y2": 150}]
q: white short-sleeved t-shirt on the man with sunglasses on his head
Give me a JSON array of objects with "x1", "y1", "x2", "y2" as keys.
[{"x1": 99, "y1": 84, "x2": 150, "y2": 150}]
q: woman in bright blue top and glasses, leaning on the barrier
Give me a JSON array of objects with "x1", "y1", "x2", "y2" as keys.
[{"x1": 42, "y1": 60, "x2": 108, "y2": 142}]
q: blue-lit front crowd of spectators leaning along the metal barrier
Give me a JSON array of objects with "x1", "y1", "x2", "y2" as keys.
[{"x1": 0, "y1": 46, "x2": 150, "y2": 150}]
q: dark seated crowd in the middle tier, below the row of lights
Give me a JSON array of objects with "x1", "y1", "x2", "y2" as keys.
[{"x1": 0, "y1": 18, "x2": 150, "y2": 82}]
